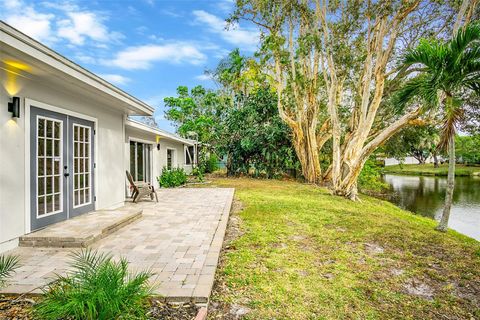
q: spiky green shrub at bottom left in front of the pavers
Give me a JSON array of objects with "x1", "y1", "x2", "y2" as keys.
[{"x1": 34, "y1": 250, "x2": 152, "y2": 320}]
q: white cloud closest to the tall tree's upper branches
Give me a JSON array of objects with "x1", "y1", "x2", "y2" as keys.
[{"x1": 193, "y1": 10, "x2": 260, "y2": 51}]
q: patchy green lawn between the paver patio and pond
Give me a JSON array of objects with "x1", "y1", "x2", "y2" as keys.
[{"x1": 209, "y1": 179, "x2": 480, "y2": 319}]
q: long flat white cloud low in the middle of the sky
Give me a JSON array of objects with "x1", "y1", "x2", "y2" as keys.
[{"x1": 109, "y1": 42, "x2": 207, "y2": 70}]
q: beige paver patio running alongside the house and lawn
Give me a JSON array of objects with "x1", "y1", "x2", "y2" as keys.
[{"x1": 0, "y1": 188, "x2": 234, "y2": 303}]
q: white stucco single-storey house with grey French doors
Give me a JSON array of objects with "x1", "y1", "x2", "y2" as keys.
[{"x1": 0, "y1": 21, "x2": 196, "y2": 252}]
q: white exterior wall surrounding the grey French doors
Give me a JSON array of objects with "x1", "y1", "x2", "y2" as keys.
[{"x1": 0, "y1": 79, "x2": 125, "y2": 248}]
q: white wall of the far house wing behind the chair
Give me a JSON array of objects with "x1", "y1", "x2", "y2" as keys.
[{"x1": 125, "y1": 126, "x2": 192, "y2": 187}]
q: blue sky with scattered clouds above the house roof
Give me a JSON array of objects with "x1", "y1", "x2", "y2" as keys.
[{"x1": 0, "y1": 0, "x2": 258, "y2": 131}]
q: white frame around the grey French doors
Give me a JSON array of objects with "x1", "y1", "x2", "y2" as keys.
[{"x1": 24, "y1": 98, "x2": 98, "y2": 234}]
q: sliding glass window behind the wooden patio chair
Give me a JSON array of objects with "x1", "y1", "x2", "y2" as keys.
[{"x1": 130, "y1": 141, "x2": 151, "y2": 182}]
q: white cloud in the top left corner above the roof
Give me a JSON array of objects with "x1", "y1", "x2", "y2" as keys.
[{"x1": 0, "y1": 0, "x2": 55, "y2": 43}]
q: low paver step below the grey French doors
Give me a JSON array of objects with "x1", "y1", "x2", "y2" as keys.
[{"x1": 19, "y1": 207, "x2": 143, "y2": 248}]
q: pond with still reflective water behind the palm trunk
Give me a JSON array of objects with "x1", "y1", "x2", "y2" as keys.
[{"x1": 383, "y1": 174, "x2": 480, "y2": 241}]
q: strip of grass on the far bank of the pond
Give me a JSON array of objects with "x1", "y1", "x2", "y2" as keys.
[{"x1": 384, "y1": 163, "x2": 480, "y2": 176}]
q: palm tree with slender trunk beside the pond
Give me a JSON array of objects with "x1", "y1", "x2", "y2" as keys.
[{"x1": 398, "y1": 23, "x2": 480, "y2": 232}]
